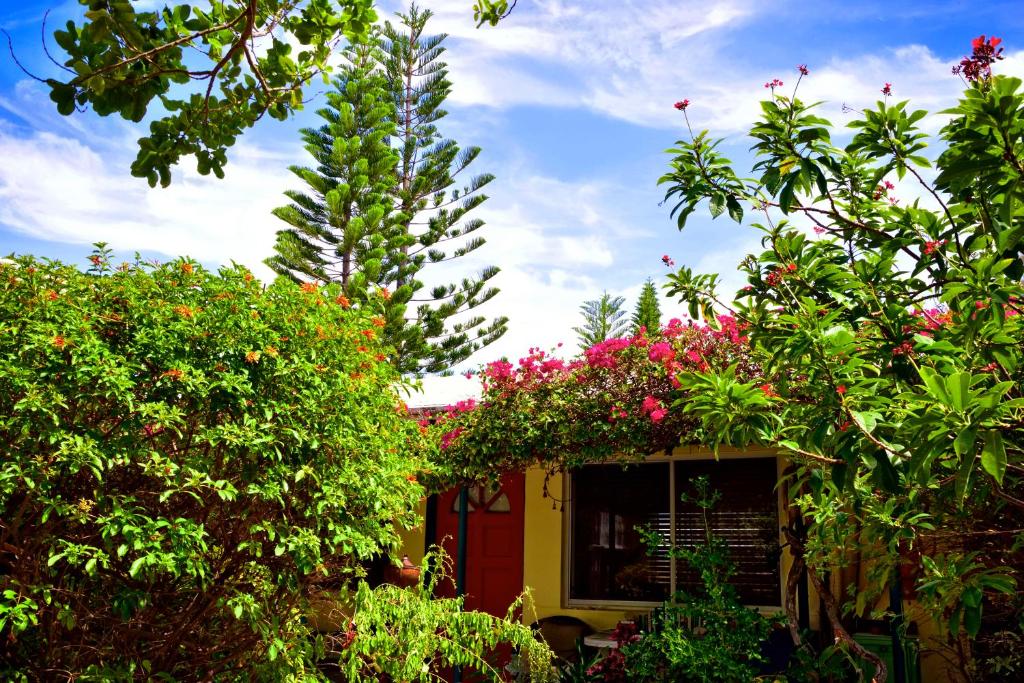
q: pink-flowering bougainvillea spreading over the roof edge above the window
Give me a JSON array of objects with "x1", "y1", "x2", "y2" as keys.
[{"x1": 424, "y1": 316, "x2": 759, "y2": 481}]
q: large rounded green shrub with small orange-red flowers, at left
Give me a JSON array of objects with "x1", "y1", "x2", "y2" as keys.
[{"x1": 0, "y1": 251, "x2": 440, "y2": 681}]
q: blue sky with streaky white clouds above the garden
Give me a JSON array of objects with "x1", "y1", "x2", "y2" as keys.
[{"x1": 0, "y1": 0, "x2": 1024, "y2": 382}]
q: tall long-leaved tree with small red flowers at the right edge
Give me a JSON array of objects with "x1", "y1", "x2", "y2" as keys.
[{"x1": 662, "y1": 36, "x2": 1024, "y2": 680}]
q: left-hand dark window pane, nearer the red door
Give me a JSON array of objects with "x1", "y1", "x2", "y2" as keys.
[{"x1": 569, "y1": 463, "x2": 670, "y2": 601}]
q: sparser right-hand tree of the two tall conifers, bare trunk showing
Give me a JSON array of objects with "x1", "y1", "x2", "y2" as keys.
[{"x1": 380, "y1": 3, "x2": 508, "y2": 372}]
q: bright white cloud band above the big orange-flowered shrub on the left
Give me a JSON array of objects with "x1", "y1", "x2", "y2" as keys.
[{"x1": 0, "y1": 120, "x2": 294, "y2": 273}]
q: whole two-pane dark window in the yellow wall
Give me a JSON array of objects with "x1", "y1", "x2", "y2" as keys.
[{"x1": 567, "y1": 458, "x2": 781, "y2": 606}]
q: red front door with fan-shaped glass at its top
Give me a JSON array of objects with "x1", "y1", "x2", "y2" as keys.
[{"x1": 437, "y1": 472, "x2": 526, "y2": 616}]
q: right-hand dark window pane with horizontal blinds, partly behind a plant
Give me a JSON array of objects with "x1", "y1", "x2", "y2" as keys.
[{"x1": 676, "y1": 458, "x2": 780, "y2": 605}]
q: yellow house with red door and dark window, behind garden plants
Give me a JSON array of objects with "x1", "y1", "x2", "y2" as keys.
[{"x1": 403, "y1": 378, "x2": 954, "y2": 681}]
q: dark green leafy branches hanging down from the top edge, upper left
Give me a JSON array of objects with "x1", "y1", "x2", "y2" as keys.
[{"x1": 39, "y1": 0, "x2": 515, "y2": 186}]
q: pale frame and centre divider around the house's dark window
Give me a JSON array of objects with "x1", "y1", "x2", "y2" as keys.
[{"x1": 561, "y1": 449, "x2": 785, "y2": 614}]
